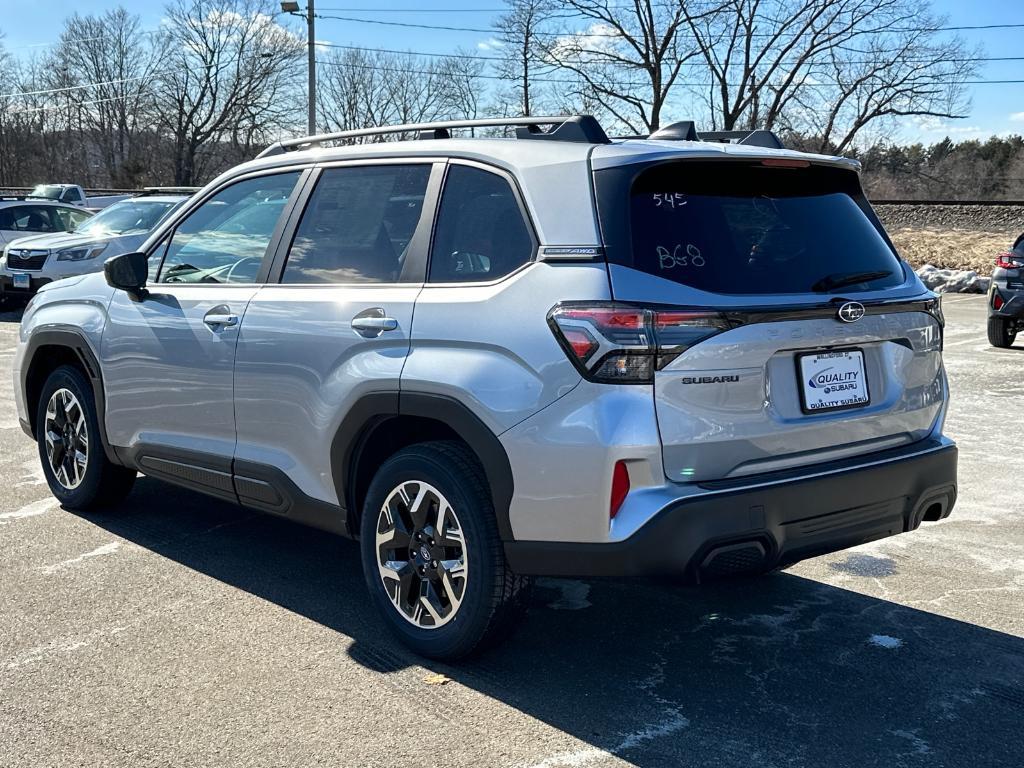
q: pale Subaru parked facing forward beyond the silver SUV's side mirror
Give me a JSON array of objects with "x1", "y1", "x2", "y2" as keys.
[{"x1": 0, "y1": 195, "x2": 187, "y2": 299}]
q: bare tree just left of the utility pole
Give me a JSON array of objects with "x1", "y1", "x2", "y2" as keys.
[{"x1": 156, "y1": 0, "x2": 303, "y2": 184}]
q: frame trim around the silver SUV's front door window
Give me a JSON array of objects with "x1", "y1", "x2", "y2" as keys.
[{"x1": 143, "y1": 165, "x2": 312, "y2": 290}]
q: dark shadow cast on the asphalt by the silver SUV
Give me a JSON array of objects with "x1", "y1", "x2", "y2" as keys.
[{"x1": 75, "y1": 478, "x2": 1024, "y2": 768}]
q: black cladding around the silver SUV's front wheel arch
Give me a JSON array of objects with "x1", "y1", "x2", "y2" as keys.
[{"x1": 22, "y1": 330, "x2": 121, "y2": 464}]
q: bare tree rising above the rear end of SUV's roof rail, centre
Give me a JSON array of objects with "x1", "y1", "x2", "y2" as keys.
[{"x1": 543, "y1": 0, "x2": 714, "y2": 133}]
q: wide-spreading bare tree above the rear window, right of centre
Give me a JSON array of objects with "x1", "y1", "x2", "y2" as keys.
[{"x1": 685, "y1": 0, "x2": 973, "y2": 146}]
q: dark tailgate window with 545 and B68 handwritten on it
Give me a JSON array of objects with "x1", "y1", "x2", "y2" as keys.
[{"x1": 630, "y1": 162, "x2": 904, "y2": 294}]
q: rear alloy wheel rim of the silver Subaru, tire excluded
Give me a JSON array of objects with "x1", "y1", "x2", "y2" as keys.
[{"x1": 375, "y1": 480, "x2": 469, "y2": 629}]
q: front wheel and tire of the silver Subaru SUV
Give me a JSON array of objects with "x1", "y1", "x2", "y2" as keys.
[{"x1": 36, "y1": 366, "x2": 135, "y2": 512}]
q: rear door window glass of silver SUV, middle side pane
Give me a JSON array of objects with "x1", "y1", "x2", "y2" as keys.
[{"x1": 282, "y1": 165, "x2": 430, "y2": 283}]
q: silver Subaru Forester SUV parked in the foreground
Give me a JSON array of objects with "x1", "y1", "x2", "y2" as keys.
[{"x1": 15, "y1": 116, "x2": 956, "y2": 658}]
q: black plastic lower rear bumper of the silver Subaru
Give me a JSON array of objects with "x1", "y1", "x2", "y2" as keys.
[{"x1": 505, "y1": 439, "x2": 956, "y2": 582}]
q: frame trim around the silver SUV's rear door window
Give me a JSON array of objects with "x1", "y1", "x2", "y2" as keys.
[{"x1": 266, "y1": 157, "x2": 445, "y2": 290}]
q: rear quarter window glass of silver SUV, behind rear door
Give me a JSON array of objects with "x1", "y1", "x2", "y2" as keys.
[{"x1": 429, "y1": 165, "x2": 534, "y2": 283}]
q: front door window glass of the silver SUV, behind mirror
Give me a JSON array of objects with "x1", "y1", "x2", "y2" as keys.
[{"x1": 158, "y1": 171, "x2": 299, "y2": 283}]
